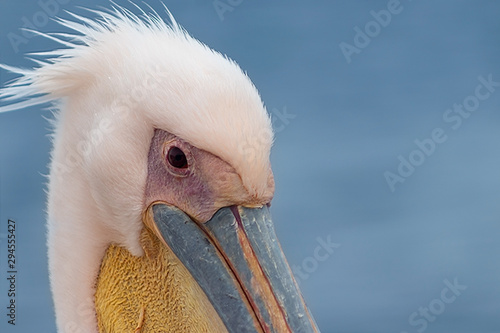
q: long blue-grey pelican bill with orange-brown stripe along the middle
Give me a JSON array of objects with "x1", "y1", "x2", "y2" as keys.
[{"x1": 145, "y1": 203, "x2": 319, "y2": 333}]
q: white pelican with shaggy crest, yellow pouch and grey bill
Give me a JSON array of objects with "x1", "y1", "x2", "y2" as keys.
[{"x1": 0, "y1": 6, "x2": 319, "y2": 333}]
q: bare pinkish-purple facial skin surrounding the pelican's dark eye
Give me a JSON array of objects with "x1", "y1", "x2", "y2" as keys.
[{"x1": 144, "y1": 129, "x2": 274, "y2": 222}]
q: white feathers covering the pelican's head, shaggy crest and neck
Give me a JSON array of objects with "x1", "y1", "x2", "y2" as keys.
[{"x1": 0, "y1": 4, "x2": 273, "y2": 332}]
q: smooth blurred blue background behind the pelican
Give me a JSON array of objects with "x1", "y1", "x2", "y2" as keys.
[{"x1": 0, "y1": 0, "x2": 500, "y2": 333}]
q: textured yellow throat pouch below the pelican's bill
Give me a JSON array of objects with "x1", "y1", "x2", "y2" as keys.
[{"x1": 95, "y1": 228, "x2": 227, "y2": 333}]
